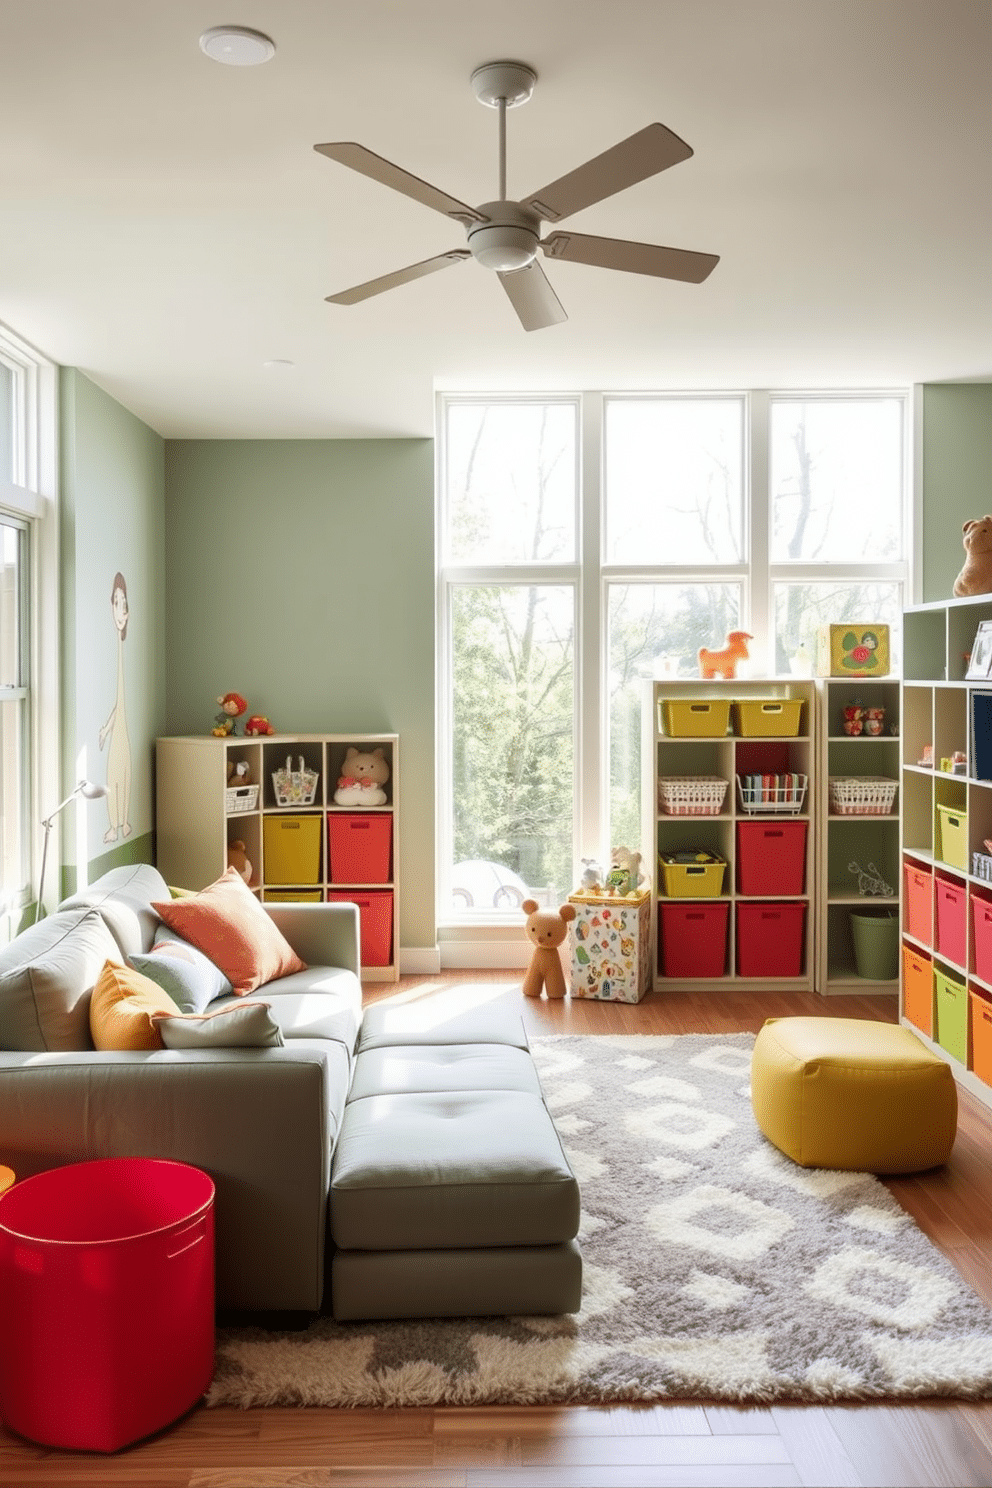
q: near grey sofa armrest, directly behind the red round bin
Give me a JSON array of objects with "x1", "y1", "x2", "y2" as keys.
[{"x1": 0, "y1": 1039, "x2": 350, "y2": 1311}]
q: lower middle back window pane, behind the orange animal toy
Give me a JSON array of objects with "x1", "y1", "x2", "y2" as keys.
[{"x1": 608, "y1": 583, "x2": 741, "y2": 848}]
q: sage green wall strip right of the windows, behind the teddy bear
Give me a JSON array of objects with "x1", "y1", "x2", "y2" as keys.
[{"x1": 921, "y1": 382, "x2": 992, "y2": 600}]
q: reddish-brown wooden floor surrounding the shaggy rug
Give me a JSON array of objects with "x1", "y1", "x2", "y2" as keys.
[{"x1": 0, "y1": 972, "x2": 992, "y2": 1488}]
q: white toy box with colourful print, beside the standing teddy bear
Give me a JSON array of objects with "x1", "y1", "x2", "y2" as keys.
[{"x1": 568, "y1": 888, "x2": 651, "y2": 1003}]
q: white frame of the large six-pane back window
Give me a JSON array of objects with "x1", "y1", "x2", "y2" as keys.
[{"x1": 436, "y1": 388, "x2": 918, "y2": 967}]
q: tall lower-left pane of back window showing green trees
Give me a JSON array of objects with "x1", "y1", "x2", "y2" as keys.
[{"x1": 451, "y1": 583, "x2": 576, "y2": 914}]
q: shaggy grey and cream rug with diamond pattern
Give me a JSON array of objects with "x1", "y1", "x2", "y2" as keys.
[{"x1": 207, "y1": 1034, "x2": 992, "y2": 1406}]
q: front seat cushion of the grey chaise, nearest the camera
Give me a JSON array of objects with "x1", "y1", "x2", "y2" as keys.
[{"x1": 330, "y1": 1091, "x2": 579, "y2": 1250}]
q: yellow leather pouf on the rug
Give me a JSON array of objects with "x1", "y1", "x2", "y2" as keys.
[{"x1": 751, "y1": 1018, "x2": 958, "y2": 1173}]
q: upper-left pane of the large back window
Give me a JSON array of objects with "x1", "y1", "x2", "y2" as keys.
[{"x1": 445, "y1": 402, "x2": 579, "y2": 565}]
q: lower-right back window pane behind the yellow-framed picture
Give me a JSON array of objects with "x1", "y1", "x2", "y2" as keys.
[{"x1": 773, "y1": 576, "x2": 906, "y2": 686}]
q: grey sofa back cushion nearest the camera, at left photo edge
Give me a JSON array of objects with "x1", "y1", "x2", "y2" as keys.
[{"x1": 0, "y1": 909, "x2": 120, "y2": 1054}]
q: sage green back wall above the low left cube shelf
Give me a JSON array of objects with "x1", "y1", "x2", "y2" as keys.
[{"x1": 165, "y1": 439, "x2": 436, "y2": 948}]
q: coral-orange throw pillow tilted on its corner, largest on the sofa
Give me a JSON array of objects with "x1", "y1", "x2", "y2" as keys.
[{"x1": 152, "y1": 868, "x2": 306, "y2": 997}]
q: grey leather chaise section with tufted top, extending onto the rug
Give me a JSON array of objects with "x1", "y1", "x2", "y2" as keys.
[{"x1": 330, "y1": 1004, "x2": 582, "y2": 1321}]
